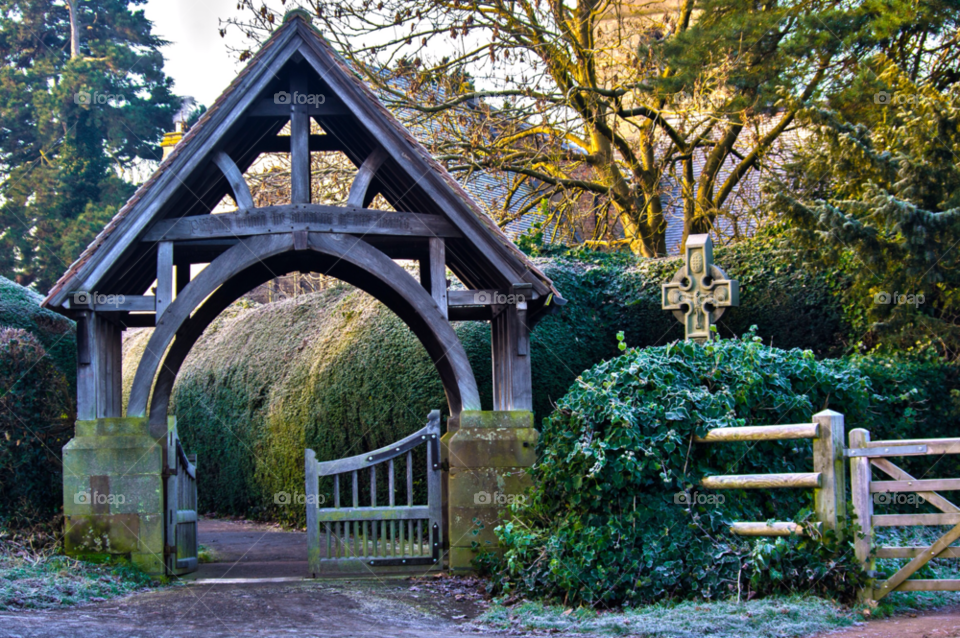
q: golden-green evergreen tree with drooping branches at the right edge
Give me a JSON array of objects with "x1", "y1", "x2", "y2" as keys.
[{"x1": 768, "y1": 62, "x2": 960, "y2": 358}]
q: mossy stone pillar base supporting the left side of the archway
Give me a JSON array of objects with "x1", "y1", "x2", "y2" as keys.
[{"x1": 63, "y1": 417, "x2": 164, "y2": 574}]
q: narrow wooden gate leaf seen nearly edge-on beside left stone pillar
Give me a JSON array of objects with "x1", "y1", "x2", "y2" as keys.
[{"x1": 163, "y1": 423, "x2": 199, "y2": 575}]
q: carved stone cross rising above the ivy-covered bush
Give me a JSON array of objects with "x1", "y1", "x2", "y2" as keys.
[{"x1": 663, "y1": 235, "x2": 740, "y2": 343}]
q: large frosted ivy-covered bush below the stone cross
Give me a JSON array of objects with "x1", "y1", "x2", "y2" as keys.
[{"x1": 495, "y1": 333, "x2": 944, "y2": 605}]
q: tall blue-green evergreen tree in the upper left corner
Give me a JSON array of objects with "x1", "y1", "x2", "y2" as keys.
[{"x1": 0, "y1": 0, "x2": 180, "y2": 292}]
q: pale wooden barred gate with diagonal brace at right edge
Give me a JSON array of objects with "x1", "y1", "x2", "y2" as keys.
[{"x1": 846, "y1": 429, "x2": 960, "y2": 600}]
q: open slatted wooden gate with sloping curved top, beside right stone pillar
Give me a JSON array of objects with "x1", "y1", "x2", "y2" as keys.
[{"x1": 305, "y1": 410, "x2": 443, "y2": 577}]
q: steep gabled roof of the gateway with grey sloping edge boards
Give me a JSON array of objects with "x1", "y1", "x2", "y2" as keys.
[{"x1": 44, "y1": 10, "x2": 559, "y2": 307}]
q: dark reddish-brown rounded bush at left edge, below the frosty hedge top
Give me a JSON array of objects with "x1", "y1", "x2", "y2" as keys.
[{"x1": 0, "y1": 327, "x2": 76, "y2": 527}]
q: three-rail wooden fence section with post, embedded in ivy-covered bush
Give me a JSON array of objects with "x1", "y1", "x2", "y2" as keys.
[{"x1": 695, "y1": 410, "x2": 846, "y2": 536}]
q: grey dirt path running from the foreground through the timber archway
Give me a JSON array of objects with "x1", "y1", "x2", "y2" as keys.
[{"x1": 0, "y1": 520, "x2": 501, "y2": 638}]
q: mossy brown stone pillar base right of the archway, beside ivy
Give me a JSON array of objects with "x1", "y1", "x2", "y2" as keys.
[{"x1": 442, "y1": 411, "x2": 537, "y2": 571}]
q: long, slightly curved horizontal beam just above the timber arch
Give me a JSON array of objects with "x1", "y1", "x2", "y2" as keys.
[{"x1": 143, "y1": 204, "x2": 460, "y2": 243}]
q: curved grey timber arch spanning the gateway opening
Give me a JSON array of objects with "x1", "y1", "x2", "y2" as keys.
[{"x1": 127, "y1": 231, "x2": 480, "y2": 425}]
